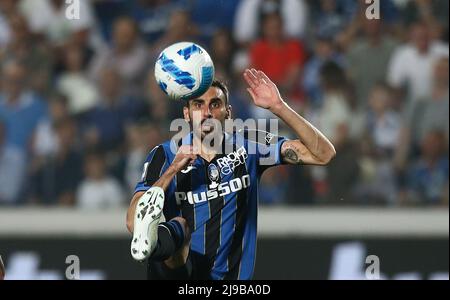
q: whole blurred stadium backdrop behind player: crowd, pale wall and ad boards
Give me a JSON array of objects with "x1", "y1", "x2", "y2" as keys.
[{"x1": 0, "y1": 0, "x2": 449, "y2": 279}]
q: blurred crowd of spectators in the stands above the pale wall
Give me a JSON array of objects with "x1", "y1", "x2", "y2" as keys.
[{"x1": 0, "y1": 0, "x2": 449, "y2": 209}]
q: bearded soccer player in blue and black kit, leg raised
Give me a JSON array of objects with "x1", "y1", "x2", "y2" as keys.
[{"x1": 127, "y1": 69, "x2": 335, "y2": 280}]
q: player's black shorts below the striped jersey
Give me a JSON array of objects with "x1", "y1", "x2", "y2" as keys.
[{"x1": 147, "y1": 251, "x2": 212, "y2": 280}]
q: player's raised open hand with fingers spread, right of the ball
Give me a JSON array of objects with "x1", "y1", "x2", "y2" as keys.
[{"x1": 244, "y1": 69, "x2": 283, "y2": 110}]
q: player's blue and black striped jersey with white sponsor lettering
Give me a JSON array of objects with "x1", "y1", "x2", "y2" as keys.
[{"x1": 135, "y1": 131, "x2": 286, "y2": 280}]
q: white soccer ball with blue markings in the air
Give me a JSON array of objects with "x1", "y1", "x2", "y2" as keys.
[{"x1": 155, "y1": 42, "x2": 214, "y2": 100}]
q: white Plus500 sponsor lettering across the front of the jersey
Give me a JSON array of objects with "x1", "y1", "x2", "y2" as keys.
[{"x1": 175, "y1": 175, "x2": 250, "y2": 205}]
